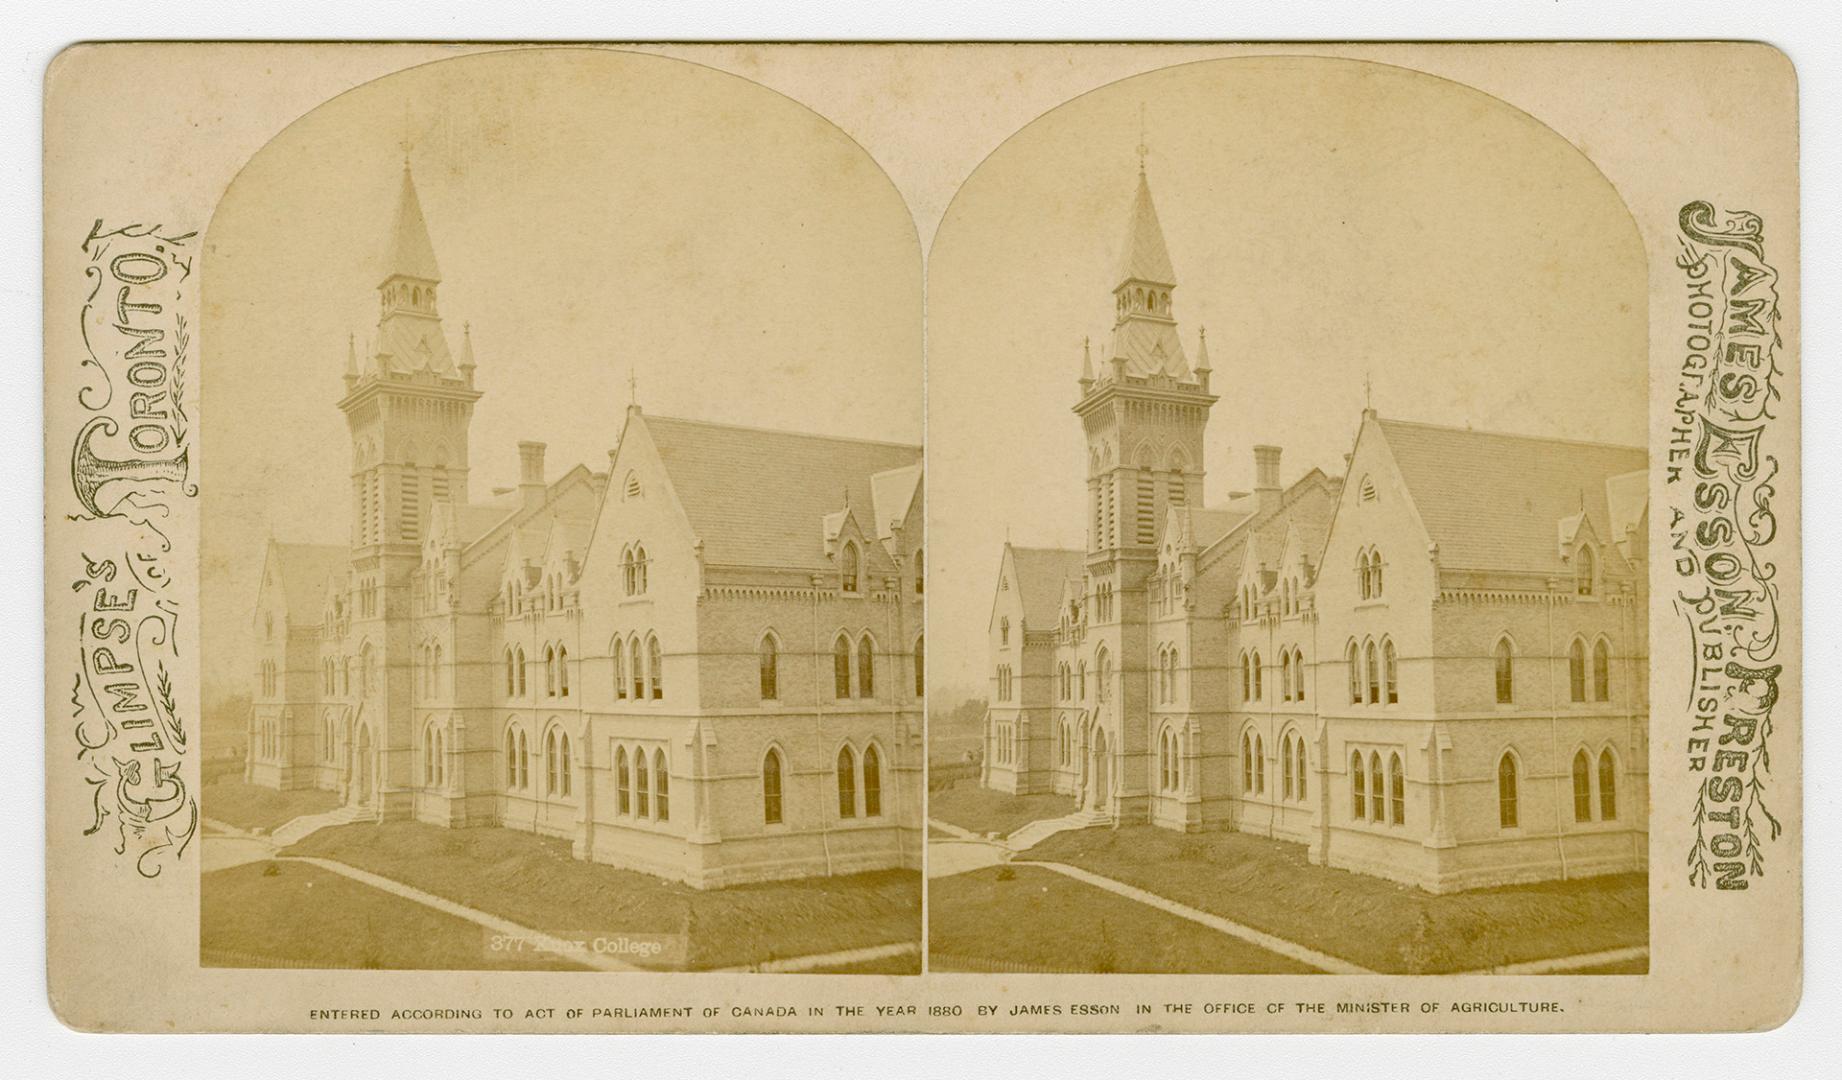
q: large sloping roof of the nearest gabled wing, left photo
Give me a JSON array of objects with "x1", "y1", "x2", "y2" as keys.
[{"x1": 639, "y1": 415, "x2": 921, "y2": 571}]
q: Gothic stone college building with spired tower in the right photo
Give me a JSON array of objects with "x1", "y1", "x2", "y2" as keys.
[{"x1": 984, "y1": 171, "x2": 1649, "y2": 892}]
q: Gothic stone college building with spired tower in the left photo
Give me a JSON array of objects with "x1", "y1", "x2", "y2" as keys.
[{"x1": 247, "y1": 168, "x2": 925, "y2": 886}]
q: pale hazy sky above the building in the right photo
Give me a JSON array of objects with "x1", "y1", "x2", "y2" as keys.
[{"x1": 928, "y1": 57, "x2": 1647, "y2": 704}]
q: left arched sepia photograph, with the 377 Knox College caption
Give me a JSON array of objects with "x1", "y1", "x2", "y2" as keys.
[{"x1": 199, "y1": 50, "x2": 925, "y2": 973}]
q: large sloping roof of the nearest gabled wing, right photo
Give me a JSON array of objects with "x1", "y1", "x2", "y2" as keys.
[{"x1": 1376, "y1": 420, "x2": 1649, "y2": 573}]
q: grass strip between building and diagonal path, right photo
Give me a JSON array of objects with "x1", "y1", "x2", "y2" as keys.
[{"x1": 1030, "y1": 826, "x2": 1650, "y2": 973}]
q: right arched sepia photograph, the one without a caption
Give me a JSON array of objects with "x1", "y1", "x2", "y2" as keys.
[{"x1": 928, "y1": 57, "x2": 1649, "y2": 973}]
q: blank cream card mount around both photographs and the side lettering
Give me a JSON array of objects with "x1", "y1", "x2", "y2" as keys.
[{"x1": 44, "y1": 44, "x2": 1801, "y2": 1030}]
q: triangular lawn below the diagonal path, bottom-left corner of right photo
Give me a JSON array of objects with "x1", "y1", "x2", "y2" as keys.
[{"x1": 928, "y1": 866, "x2": 1317, "y2": 975}]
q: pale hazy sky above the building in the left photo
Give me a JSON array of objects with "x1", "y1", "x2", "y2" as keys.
[{"x1": 199, "y1": 50, "x2": 923, "y2": 700}]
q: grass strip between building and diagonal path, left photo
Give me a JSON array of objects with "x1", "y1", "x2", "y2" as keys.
[{"x1": 284, "y1": 822, "x2": 921, "y2": 969}]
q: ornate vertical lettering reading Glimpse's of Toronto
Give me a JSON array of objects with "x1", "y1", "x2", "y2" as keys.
[{"x1": 69, "y1": 219, "x2": 199, "y2": 877}]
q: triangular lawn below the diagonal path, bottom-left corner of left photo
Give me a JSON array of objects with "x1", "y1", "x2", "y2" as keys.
[{"x1": 199, "y1": 863, "x2": 586, "y2": 971}]
